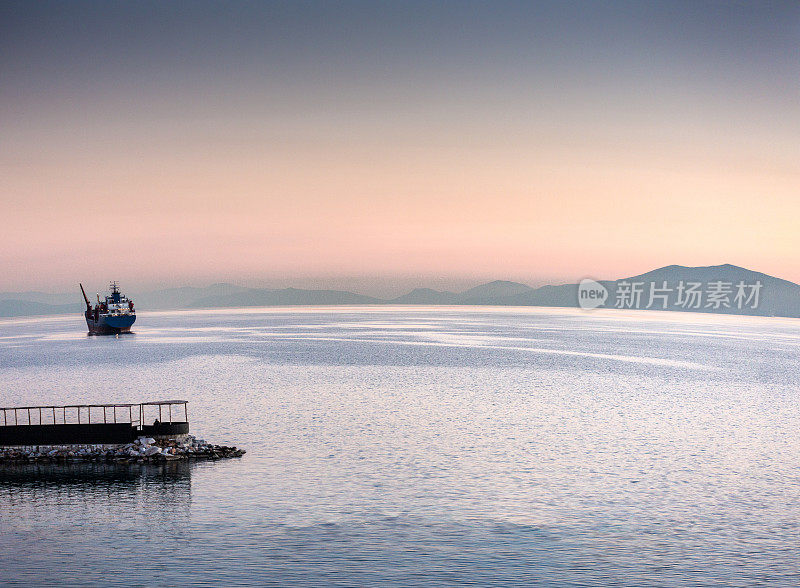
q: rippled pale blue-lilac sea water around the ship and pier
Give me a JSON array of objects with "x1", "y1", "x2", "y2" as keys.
[{"x1": 0, "y1": 307, "x2": 800, "y2": 587}]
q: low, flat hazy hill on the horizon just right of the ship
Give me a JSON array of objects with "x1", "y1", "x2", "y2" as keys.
[{"x1": 190, "y1": 288, "x2": 386, "y2": 308}]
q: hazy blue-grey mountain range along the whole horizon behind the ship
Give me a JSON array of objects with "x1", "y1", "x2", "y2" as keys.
[{"x1": 0, "y1": 264, "x2": 800, "y2": 317}]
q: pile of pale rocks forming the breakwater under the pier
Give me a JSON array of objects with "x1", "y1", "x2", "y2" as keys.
[{"x1": 0, "y1": 435, "x2": 246, "y2": 463}]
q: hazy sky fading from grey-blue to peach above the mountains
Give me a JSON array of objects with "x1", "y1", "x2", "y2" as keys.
[{"x1": 0, "y1": 0, "x2": 800, "y2": 295}]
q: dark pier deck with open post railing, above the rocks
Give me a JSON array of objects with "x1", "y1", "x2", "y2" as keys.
[{"x1": 0, "y1": 400, "x2": 189, "y2": 445}]
